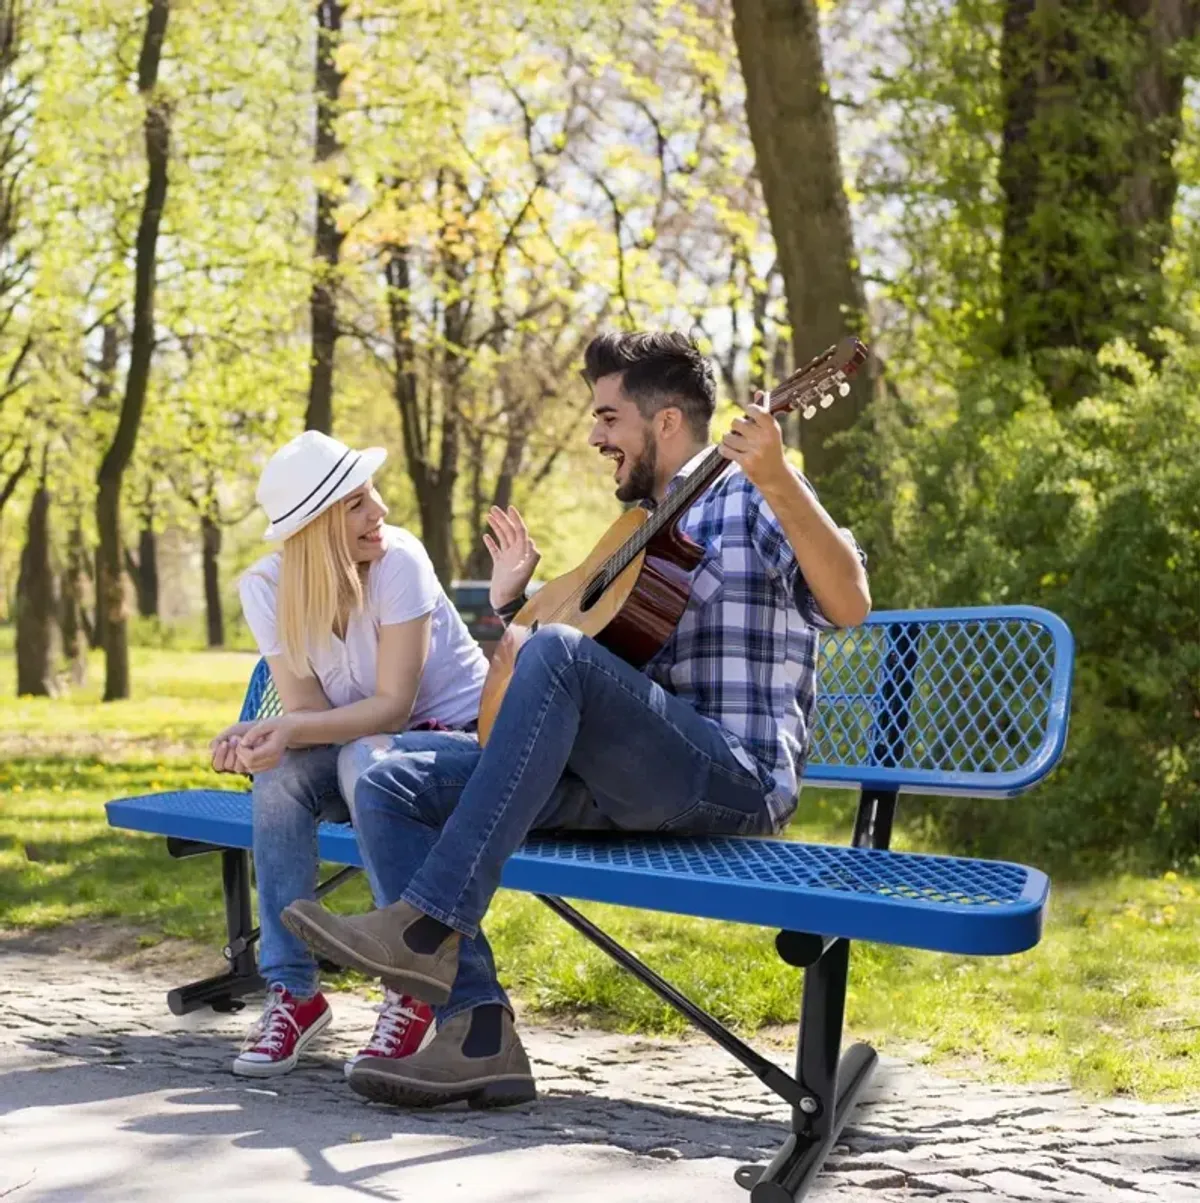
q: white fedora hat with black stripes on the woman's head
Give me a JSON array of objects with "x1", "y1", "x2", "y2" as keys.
[{"x1": 255, "y1": 431, "x2": 387, "y2": 543}]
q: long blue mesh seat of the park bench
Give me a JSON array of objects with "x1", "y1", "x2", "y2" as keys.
[{"x1": 107, "y1": 789, "x2": 1050, "y2": 955}]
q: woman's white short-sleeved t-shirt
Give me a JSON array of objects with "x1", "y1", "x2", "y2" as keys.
[{"x1": 238, "y1": 526, "x2": 487, "y2": 727}]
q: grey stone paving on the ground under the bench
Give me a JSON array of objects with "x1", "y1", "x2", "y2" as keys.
[{"x1": 0, "y1": 941, "x2": 1200, "y2": 1203}]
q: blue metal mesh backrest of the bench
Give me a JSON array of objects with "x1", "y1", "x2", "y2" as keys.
[{"x1": 242, "y1": 606, "x2": 1074, "y2": 798}]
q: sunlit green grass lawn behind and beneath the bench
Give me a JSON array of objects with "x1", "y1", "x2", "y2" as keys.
[{"x1": 0, "y1": 645, "x2": 1200, "y2": 1098}]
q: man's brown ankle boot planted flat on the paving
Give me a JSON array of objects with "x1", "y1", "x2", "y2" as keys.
[{"x1": 350, "y1": 1003, "x2": 537, "y2": 1109}]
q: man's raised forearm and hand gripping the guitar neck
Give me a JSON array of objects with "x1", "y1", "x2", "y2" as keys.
[{"x1": 720, "y1": 392, "x2": 871, "y2": 627}]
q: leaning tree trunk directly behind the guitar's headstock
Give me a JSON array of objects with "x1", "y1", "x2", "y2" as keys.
[{"x1": 733, "y1": 0, "x2": 874, "y2": 481}]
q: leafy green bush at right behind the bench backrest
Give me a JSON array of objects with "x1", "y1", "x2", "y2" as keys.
[{"x1": 862, "y1": 345, "x2": 1200, "y2": 871}]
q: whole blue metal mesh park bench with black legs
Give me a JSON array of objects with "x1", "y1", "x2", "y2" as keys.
[{"x1": 107, "y1": 606, "x2": 1074, "y2": 1203}]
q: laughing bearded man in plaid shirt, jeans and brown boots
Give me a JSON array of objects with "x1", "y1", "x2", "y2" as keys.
[{"x1": 284, "y1": 333, "x2": 871, "y2": 1106}]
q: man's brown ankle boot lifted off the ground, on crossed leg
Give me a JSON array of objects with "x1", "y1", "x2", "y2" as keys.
[{"x1": 283, "y1": 899, "x2": 461, "y2": 1006}]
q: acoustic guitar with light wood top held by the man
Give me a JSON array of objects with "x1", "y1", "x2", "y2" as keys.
[{"x1": 479, "y1": 338, "x2": 867, "y2": 743}]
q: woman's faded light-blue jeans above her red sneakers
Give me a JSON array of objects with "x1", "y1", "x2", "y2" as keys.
[{"x1": 254, "y1": 735, "x2": 384, "y2": 998}]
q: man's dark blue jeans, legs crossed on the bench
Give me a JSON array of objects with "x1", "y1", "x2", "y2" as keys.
[{"x1": 354, "y1": 626, "x2": 771, "y2": 1021}]
